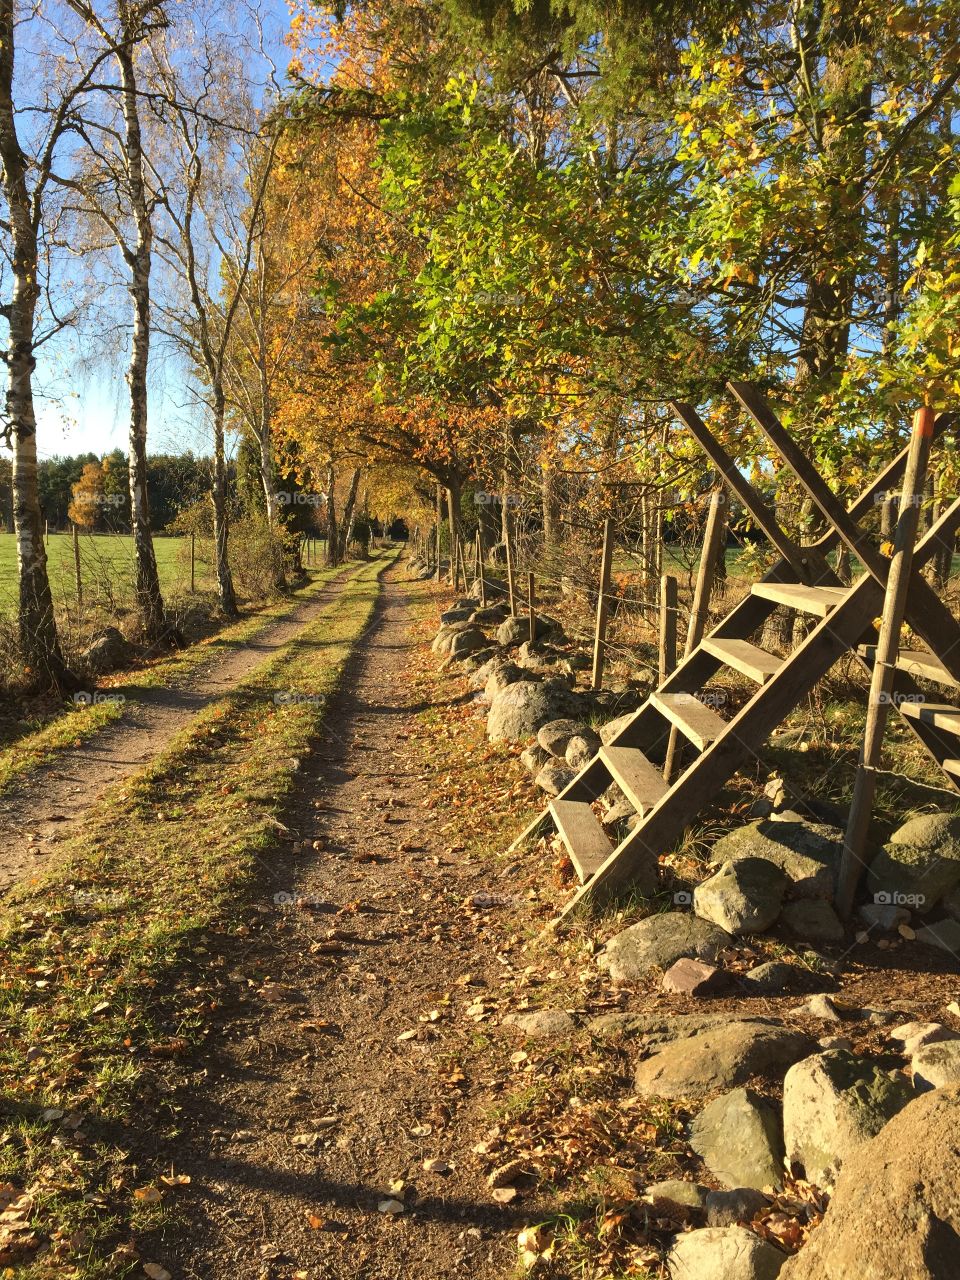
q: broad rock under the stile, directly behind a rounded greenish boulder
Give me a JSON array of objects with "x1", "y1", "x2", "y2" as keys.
[{"x1": 710, "y1": 819, "x2": 844, "y2": 899}]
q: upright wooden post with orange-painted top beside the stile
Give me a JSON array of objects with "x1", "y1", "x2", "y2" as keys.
[{"x1": 837, "y1": 408, "x2": 933, "y2": 918}]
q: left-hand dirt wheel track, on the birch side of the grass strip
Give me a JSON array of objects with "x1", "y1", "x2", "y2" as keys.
[{"x1": 0, "y1": 570, "x2": 368, "y2": 896}]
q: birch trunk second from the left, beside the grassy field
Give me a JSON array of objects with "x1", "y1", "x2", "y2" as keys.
[{"x1": 116, "y1": 32, "x2": 164, "y2": 640}]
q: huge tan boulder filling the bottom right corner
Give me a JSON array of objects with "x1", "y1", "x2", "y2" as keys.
[{"x1": 781, "y1": 1088, "x2": 960, "y2": 1280}]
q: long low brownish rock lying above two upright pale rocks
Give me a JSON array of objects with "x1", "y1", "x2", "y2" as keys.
[{"x1": 634, "y1": 1020, "x2": 813, "y2": 1098}]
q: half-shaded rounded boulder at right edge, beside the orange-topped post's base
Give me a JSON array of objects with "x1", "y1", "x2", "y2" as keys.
[{"x1": 867, "y1": 813, "x2": 960, "y2": 915}]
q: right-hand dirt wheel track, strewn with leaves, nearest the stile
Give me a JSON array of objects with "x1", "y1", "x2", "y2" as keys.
[{"x1": 134, "y1": 568, "x2": 525, "y2": 1280}]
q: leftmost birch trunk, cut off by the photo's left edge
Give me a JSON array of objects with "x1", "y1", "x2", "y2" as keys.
[{"x1": 0, "y1": 0, "x2": 74, "y2": 689}]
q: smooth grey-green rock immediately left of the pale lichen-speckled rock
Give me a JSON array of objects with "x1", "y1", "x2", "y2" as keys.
[{"x1": 690, "y1": 1089, "x2": 783, "y2": 1190}]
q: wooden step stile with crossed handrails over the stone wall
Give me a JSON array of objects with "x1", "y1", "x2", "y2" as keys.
[{"x1": 511, "y1": 383, "x2": 960, "y2": 919}]
